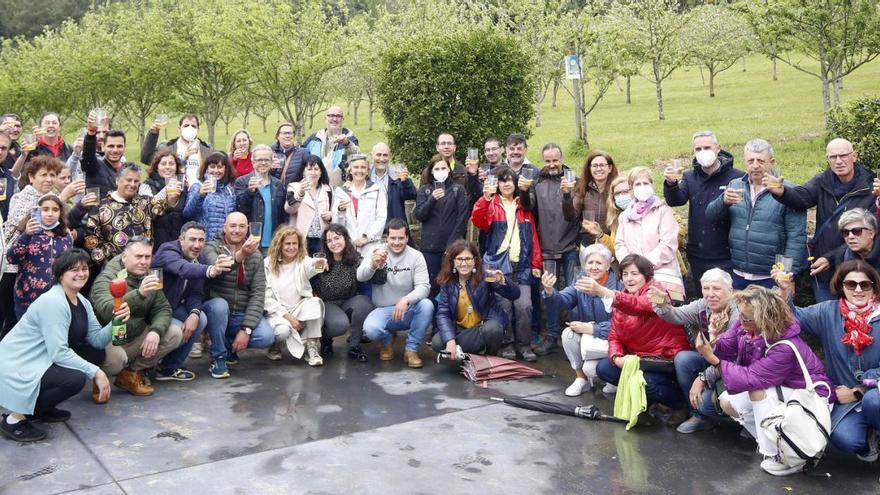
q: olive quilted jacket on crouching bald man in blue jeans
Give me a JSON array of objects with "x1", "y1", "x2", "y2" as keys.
[{"x1": 205, "y1": 231, "x2": 266, "y2": 328}]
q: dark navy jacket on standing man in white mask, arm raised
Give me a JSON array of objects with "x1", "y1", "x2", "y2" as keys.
[{"x1": 663, "y1": 150, "x2": 745, "y2": 261}]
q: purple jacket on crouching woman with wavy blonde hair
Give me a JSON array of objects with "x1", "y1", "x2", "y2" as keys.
[{"x1": 715, "y1": 320, "x2": 834, "y2": 399}]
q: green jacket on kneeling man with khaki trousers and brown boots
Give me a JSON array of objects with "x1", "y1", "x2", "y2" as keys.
[{"x1": 89, "y1": 254, "x2": 171, "y2": 342}]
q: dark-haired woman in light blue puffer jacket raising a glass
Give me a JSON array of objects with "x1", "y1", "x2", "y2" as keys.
[{"x1": 182, "y1": 152, "x2": 236, "y2": 242}]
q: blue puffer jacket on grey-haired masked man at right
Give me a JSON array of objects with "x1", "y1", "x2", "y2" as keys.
[{"x1": 706, "y1": 179, "x2": 807, "y2": 275}]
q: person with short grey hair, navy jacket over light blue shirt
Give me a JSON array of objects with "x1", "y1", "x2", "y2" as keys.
[{"x1": 235, "y1": 144, "x2": 284, "y2": 252}]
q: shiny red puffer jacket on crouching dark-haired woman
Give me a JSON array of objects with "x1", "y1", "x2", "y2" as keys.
[{"x1": 608, "y1": 283, "x2": 690, "y2": 359}]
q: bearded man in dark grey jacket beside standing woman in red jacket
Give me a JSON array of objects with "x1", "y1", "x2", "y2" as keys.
[{"x1": 518, "y1": 143, "x2": 581, "y2": 361}]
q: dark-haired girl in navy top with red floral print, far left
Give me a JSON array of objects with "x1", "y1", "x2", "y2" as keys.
[{"x1": 6, "y1": 194, "x2": 73, "y2": 318}]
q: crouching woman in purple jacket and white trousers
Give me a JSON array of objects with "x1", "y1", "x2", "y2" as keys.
[{"x1": 696, "y1": 284, "x2": 834, "y2": 476}]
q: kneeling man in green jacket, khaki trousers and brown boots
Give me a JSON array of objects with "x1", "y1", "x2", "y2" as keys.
[{"x1": 89, "y1": 237, "x2": 183, "y2": 396}]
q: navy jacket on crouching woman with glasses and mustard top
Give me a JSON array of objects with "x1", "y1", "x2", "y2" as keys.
[{"x1": 434, "y1": 275, "x2": 519, "y2": 344}]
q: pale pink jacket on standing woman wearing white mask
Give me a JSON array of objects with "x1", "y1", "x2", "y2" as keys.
[{"x1": 614, "y1": 198, "x2": 684, "y2": 295}]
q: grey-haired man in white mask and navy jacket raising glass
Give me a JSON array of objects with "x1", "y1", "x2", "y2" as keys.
[{"x1": 663, "y1": 131, "x2": 744, "y2": 297}]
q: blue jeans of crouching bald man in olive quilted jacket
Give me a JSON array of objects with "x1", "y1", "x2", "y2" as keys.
[{"x1": 202, "y1": 297, "x2": 275, "y2": 361}]
